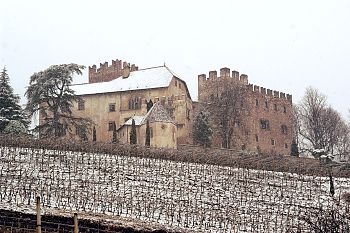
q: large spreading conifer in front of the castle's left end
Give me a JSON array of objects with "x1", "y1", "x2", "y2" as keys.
[{"x1": 25, "y1": 64, "x2": 92, "y2": 138}]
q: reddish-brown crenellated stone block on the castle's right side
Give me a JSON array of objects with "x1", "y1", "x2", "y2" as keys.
[{"x1": 198, "y1": 68, "x2": 293, "y2": 155}]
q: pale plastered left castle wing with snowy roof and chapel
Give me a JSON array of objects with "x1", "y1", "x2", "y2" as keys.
[{"x1": 72, "y1": 60, "x2": 193, "y2": 148}]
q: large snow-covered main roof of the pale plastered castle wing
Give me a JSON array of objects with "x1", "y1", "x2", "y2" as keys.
[{"x1": 71, "y1": 66, "x2": 176, "y2": 95}]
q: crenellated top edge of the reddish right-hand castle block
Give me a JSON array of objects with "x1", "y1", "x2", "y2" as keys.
[{"x1": 198, "y1": 67, "x2": 292, "y2": 103}]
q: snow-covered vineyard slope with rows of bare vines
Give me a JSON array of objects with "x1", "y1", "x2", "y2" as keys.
[{"x1": 0, "y1": 147, "x2": 350, "y2": 232}]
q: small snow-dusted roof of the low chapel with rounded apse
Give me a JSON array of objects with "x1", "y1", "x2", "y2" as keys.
[{"x1": 118, "y1": 102, "x2": 175, "y2": 130}]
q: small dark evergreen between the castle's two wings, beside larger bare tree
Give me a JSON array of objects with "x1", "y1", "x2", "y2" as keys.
[{"x1": 193, "y1": 111, "x2": 213, "y2": 147}]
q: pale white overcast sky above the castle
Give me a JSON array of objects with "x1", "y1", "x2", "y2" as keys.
[{"x1": 0, "y1": 0, "x2": 350, "y2": 118}]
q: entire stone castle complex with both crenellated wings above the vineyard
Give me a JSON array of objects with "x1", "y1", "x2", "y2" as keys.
[{"x1": 67, "y1": 59, "x2": 293, "y2": 154}]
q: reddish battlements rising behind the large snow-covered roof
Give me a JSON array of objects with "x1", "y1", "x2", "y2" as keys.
[{"x1": 89, "y1": 59, "x2": 139, "y2": 83}]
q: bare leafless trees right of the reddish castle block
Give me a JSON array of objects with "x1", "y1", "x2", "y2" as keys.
[{"x1": 295, "y1": 87, "x2": 348, "y2": 155}]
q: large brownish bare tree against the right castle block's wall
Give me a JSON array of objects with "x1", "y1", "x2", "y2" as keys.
[{"x1": 207, "y1": 78, "x2": 250, "y2": 148}]
